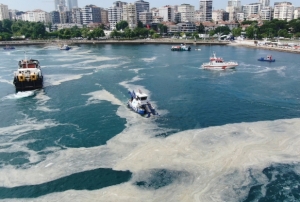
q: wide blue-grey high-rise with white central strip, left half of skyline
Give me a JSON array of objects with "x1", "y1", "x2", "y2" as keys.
[{"x1": 82, "y1": 5, "x2": 101, "y2": 25}]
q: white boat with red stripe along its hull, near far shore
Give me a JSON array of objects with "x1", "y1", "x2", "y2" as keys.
[{"x1": 202, "y1": 52, "x2": 239, "y2": 70}]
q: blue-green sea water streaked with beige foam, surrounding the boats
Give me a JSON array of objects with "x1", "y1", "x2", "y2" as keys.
[{"x1": 0, "y1": 44, "x2": 300, "y2": 202}]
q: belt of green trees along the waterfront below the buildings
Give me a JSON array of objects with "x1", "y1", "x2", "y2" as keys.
[{"x1": 0, "y1": 19, "x2": 300, "y2": 40}]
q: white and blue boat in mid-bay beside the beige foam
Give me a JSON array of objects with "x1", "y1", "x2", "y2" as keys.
[{"x1": 127, "y1": 90, "x2": 158, "y2": 117}]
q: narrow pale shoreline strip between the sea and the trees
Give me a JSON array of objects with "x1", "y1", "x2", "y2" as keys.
[{"x1": 0, "y1": 39, "x2": 300, "y2": 54}]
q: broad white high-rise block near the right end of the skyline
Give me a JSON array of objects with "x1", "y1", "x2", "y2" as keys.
[{"x1": 273, "y1": 2, "x2": 294, "y2": 21}]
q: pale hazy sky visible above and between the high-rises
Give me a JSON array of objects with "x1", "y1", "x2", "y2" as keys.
[{"x1": 0, "y1": 0, "x2": 300, "y2": 12}]
